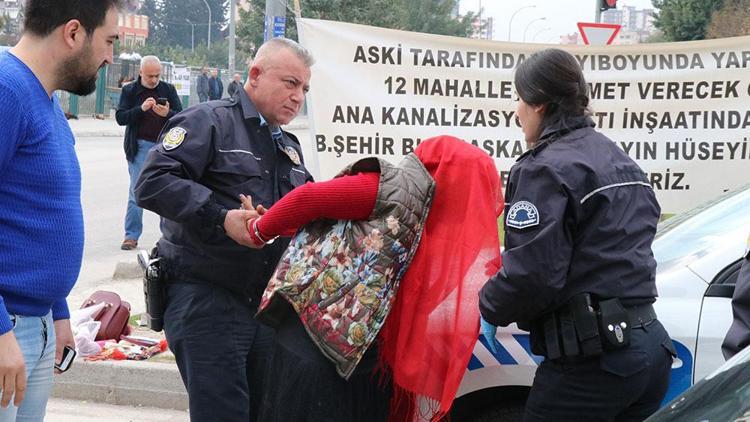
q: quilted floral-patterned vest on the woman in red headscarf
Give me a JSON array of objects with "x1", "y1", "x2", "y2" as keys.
[{"x1": 257, "y1": 154, "x2": 435, "y2": 379}]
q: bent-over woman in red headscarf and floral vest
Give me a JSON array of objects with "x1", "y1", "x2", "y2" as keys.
[{"x1": 248, "y1": 136, "x2": 503, "y2": 421}]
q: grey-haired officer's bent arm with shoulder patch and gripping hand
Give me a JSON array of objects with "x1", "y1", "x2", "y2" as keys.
[{"x1": 135, "y1": 108, "x2": 258, "y2": 246}]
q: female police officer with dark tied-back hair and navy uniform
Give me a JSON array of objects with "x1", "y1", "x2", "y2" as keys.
[{"x1": 480, "y1": 49, "x2": 674, "y2": 421}]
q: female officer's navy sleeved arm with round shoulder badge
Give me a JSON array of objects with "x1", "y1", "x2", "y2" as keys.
[{"x1": 479, "y1": 166, "x2": 573, "y2": 326}]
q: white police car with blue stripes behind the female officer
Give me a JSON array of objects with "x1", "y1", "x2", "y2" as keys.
[{"x1": 452, "y1": 185, "x2": 750, "y2": 421}]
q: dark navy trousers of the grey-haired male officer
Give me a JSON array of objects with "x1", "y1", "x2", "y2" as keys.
[{"x1": 164, "y1": 282, "x2": 273, "y2": 422}]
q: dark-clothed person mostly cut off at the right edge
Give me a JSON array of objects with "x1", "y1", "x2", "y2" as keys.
[{"x1": 721, "y1": 236, "x2": 750, "y2": 359}]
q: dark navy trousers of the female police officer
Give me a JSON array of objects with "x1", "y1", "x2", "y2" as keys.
[{"x1": 524, "y1": 321, "x2": 676, "y2": 422}]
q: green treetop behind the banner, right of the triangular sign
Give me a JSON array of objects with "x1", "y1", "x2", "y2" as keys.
[{"x1": 652, "y1": 0, "x2": 725, "y2": 41}]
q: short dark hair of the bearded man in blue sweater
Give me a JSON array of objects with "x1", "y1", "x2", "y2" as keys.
[{"x1": 23, "y1": 0, "x2": 122, "y2": 37}]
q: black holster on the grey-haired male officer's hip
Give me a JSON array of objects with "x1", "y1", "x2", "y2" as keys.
[{"x1": 138, "y1": 248, "x2": 166, "y2": 331}]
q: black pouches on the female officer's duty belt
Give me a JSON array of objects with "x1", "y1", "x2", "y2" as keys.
[{"x1": 531, "y1": 293, "x2": 631, "y2": 359}]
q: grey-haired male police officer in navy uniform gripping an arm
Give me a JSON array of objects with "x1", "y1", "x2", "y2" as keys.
[{"x1": 136, "y1": 39, "x2": 313, "y2": 421}]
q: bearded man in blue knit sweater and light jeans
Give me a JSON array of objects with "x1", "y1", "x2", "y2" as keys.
[{"x1": 0, "y1": 0, "x2": 121, "y2": 422}]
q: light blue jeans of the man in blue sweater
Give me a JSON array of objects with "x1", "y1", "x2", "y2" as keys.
[{"x1": 0, "y1": 312, "x2": 55, "y2": 422}]
